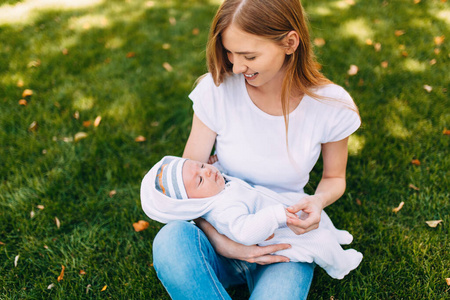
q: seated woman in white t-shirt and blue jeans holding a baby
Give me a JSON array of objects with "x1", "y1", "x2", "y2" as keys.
[{"x1": 153, "y1": 0, "x2": 360, "y2": 299}]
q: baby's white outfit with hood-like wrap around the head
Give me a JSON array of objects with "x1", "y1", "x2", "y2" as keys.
[{"x1": 141, "y1": 162, "x2": 362, "y2": 279}]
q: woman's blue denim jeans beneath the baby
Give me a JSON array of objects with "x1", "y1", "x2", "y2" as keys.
[{"x1": 153, "y1": 221, "x2": 314, "y2": 300}]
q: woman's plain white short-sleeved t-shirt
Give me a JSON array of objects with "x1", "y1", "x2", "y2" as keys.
[{"x1": 189, "y1": 74, "x2": 361, "y2": 192}]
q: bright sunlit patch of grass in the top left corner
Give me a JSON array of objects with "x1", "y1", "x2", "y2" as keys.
[{"x1": 0, "y1": 0, "x2": 103, "y2": 25}]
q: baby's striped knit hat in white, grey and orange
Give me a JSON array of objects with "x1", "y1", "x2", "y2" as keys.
[{"x1": 155, "y1": 156, "x2": 188, "y2": 199}]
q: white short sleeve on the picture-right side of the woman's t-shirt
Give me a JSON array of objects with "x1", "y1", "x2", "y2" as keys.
[{"x1": 324, "y1": 89, "x2": 361, "y2": 143}]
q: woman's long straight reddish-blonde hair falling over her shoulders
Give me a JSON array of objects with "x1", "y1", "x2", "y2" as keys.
[{"x1": 206, "y1": 0, "x2": 331, "y2": 132}]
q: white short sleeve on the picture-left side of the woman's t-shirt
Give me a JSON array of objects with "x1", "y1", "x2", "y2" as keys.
[{"x1": 189, "y1": 73, "x2": 220, "y2": 133}]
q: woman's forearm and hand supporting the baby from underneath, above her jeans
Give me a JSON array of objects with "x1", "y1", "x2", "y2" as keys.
[{"x1": 195, "y1": 218, "x2": 291, "y2": 265}]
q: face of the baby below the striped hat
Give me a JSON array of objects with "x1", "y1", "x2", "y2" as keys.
[{"x1": 183, "y1": 159, "x2": 225, "y2": 198}]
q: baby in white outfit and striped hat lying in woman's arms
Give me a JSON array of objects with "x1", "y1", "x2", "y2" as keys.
[{"x1": 141, "y1": 156, "x2": 363, "y2": 279}]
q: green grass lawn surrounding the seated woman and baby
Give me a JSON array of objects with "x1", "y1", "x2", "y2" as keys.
[{"x1": 0, "y1": 0, "x2": 450, "y2": 299}]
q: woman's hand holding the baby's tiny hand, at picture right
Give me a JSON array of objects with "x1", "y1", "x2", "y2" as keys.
[{"x1": 286, "y1": 195, "x2": 323, "y2": 235}]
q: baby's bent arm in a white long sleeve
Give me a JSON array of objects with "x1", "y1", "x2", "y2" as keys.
[{"x1": 205, "y1": 202, "x2": 287, "y2": 245}]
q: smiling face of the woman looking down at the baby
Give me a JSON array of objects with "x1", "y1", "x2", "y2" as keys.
[{"x1": 222, "y1": 24, "x2": 286, "y2": 87}]
